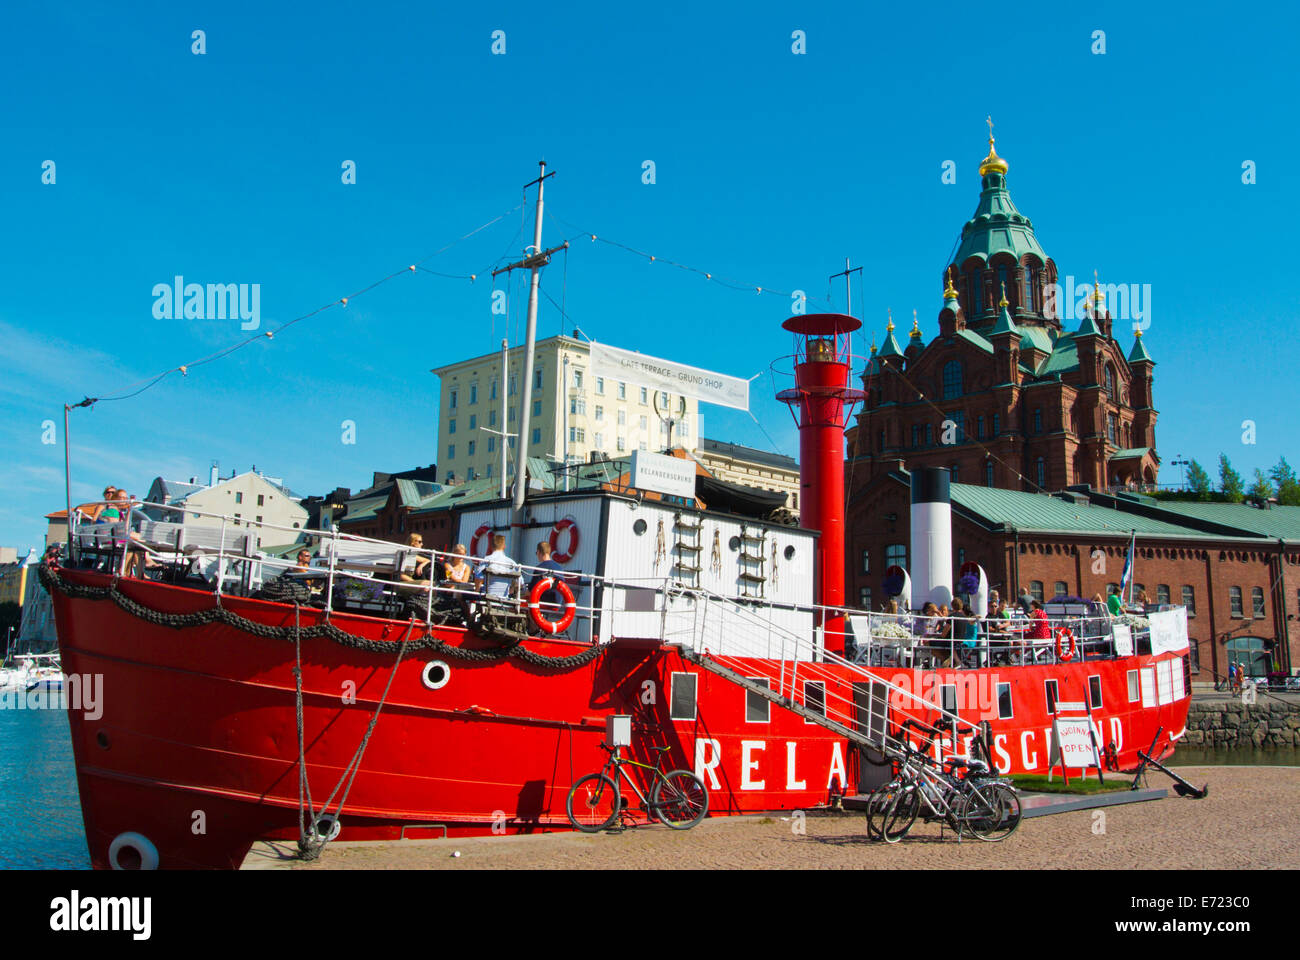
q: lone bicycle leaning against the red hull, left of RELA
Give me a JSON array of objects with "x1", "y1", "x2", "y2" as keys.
[{"x1": 564, "y1": 743, "x2": 709, "y2": 834}]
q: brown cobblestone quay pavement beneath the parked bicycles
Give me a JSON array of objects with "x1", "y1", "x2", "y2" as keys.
[{"x1": 253, "y1": 766, "x2": 1300, "y2": 870}]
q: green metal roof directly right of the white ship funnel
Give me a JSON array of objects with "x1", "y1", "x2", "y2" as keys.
[{"x1": 952, "y1": 484, "x2": 1222, "y2": 539}]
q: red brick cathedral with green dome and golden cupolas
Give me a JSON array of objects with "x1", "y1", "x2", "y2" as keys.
[{"x1": 849, "y1": 133, "x2": 1160, "y2": 490}]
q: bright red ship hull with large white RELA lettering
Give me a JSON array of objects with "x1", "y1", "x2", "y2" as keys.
[{"x1": 53, "y1": 571, "x2": 1188, "y2": 869}]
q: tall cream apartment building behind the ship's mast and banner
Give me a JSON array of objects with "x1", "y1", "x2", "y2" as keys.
[{"x1": 432, "y1": 336, "x2": 699, "y2": 483}]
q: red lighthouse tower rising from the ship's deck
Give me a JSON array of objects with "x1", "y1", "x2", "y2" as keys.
[{"x1": 776, "y1": 313, "x2": 863, "y2": 653}]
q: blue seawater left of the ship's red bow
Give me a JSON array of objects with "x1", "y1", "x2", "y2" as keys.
[{"x1": 0, "y1": 710, "x2": 90, "y2": 870}]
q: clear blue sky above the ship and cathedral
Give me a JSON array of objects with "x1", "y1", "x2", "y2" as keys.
[{"x1": 0, "y1": 3, "x2": 1300, "y2": 546}]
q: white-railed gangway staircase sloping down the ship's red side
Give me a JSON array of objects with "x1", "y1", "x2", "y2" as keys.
[{"x1": 662, "y1": 589, "x2": 982, "y2": 762}]
